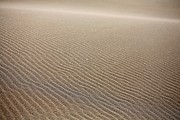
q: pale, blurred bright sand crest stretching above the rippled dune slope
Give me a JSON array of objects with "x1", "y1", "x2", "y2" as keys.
[{"x1": 0, "y1": 3, "x2": 180, "y2": 22}]
